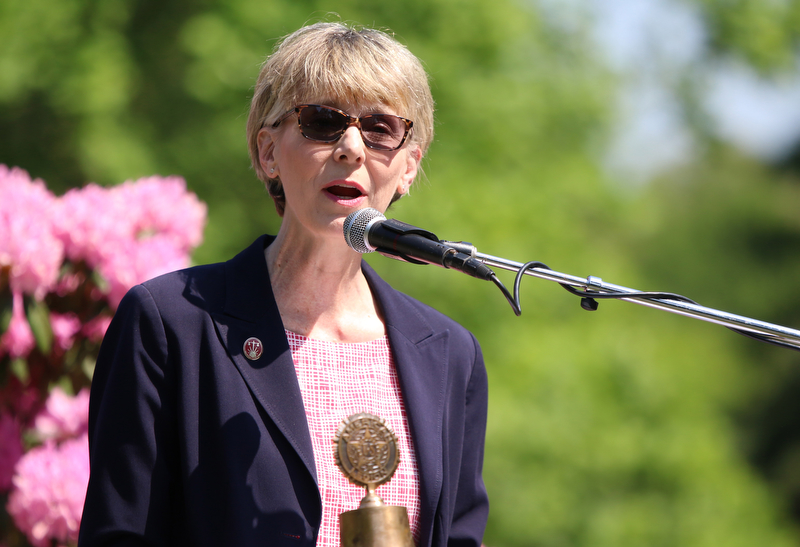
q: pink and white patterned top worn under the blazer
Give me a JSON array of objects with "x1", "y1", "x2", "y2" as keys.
[{"x1": 286, "y1": 330, "x2": 420, "y2": 547}]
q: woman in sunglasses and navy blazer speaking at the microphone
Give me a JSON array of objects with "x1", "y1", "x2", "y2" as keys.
[{"x1": 80, "y1": 23, "x2": 488, "y2": 547}]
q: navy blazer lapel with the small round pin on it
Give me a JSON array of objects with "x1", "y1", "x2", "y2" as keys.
[{"x1": 211, "y1": 236, "x2": 317, "y2": 481}]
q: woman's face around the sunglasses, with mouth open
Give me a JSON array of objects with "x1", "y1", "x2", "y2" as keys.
[{"x1": 258, "y1": 102, "x2": 421, "y2": 243}]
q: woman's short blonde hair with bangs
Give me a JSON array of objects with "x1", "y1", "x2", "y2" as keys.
[{"x1": 247, "y1": 23, "x2": 433, "y2": 214}]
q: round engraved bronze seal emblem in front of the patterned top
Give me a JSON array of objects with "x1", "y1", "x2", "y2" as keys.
[{"x1": 333, "y1": 412, "x2": 400, "y2": 492}]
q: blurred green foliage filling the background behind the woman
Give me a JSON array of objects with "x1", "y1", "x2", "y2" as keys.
[{"x1": 0, "y1": 0, "x2": 800, "y2": 547}]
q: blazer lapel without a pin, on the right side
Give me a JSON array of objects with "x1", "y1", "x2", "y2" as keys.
[{"x1": 362, "y1": 262, "x2": 449, "y2": 544}]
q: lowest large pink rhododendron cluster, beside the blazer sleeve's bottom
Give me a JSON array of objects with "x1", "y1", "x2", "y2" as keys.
[{"x1": 6, "y1": 434, "x2": 89, "y2": 547}]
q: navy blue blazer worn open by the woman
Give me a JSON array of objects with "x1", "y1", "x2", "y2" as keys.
[{"x1": 79, "y1": 236, "x2": 488, "y2": 547}]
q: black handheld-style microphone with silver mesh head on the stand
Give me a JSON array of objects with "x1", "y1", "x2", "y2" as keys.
[{"x1": 343, "y1": 208, "x2": 494, "y2": 280}]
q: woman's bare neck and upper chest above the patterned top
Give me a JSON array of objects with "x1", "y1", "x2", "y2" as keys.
[{"x1": 264, "y1": 233, "x2": 386, "y2": 342}]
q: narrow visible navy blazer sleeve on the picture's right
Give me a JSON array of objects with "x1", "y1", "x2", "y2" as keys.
[{"x1": 447, "y1": 333, "x2": 489, "y2": 547}]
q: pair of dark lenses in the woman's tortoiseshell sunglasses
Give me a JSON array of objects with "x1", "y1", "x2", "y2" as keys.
[{"x1": 298, "y1": 105, "x2": 411, "y2": 150}]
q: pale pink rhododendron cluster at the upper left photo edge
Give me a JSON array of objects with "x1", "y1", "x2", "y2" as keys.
[{"x1": 0, "y1": 164, "x2": 64, "y2": 298}]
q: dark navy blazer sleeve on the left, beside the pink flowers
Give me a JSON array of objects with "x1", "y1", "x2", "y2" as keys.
[{"x1": 79, "y1": 286, "x2": 179, "y2": 547}]
